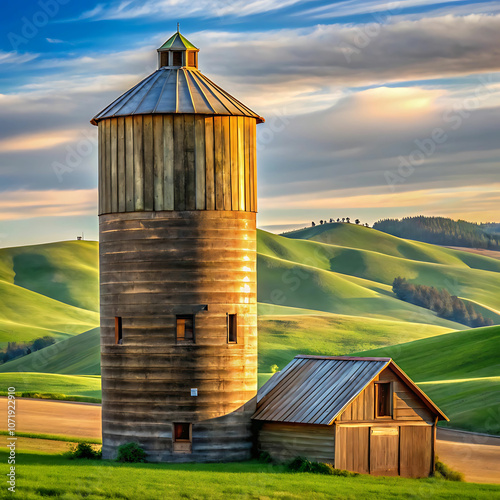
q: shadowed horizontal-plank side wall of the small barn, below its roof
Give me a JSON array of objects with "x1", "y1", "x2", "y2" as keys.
[{"x1": 259, "y1": 422, "x2": 335, "y2": 464}]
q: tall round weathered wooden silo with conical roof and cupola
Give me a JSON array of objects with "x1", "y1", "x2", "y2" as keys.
[{"x1": 92, "y1": 32, "x2": 264, "y2": 461}]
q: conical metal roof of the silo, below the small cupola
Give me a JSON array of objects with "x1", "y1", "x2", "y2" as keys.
[{"x1": 91, "y1": 67, "x2": 264, "y2": 125}]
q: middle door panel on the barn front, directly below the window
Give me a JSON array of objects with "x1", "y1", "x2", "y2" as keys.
[{"x1": 370, "y1": 427, "x2": 399, "y2": 476}]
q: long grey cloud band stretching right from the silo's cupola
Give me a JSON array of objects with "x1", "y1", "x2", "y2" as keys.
[{"x1": 197, "y1": 15, "x2": 500, "y2": 89}]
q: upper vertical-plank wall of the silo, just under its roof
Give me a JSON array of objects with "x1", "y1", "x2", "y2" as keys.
[{"x1": 99, "y1": 115, "x2": 257, "y2": 214}]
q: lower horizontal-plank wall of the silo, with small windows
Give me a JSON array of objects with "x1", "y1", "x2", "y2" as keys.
[{"x1": 99, "y1": 211, "x2": 257, "y2": 461}]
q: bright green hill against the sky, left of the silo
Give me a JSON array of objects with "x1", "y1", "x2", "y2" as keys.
[{"x1": 0, "y1": 241, "x2": 99, "y2": 345}]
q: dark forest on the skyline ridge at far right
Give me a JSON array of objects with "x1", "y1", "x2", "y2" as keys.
[{"x1": 373, "y1": 216, "x2": 500, "y2": 250}]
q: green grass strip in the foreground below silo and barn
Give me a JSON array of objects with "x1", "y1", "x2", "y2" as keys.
[{"x1": 0, "y1": 451, "x2": 500, "y2": 500}]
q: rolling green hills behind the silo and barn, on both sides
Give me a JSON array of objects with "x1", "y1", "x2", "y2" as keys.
[{"x1": 0, "y1": 224, "x2": 500, "y2": 432}]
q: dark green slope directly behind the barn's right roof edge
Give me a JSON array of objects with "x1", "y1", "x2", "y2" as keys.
[{"x1": 358, "y1": 326, "x2": 500, "y2": 434}]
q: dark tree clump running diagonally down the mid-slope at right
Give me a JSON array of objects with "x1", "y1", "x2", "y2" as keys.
[{"x1": 392, "y1": 276, "x2": 494, "y2": 328}]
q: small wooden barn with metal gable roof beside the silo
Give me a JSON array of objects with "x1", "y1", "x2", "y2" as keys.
[{"x1": 253, "y1": 355, "x2": 448, "y2": 477}]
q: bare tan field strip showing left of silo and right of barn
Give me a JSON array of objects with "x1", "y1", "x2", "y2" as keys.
[{"x1": 0, "y1": 397, "x2": 500, "y2": 484}]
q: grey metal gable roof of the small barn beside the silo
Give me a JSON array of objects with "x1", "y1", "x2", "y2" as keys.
[{"x1": 252, "y1": 355, "x2": 447, "y2": 425}]
